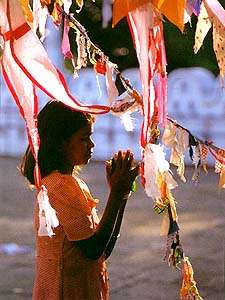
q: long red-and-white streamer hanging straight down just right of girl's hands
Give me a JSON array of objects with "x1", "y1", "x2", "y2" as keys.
[{"x1": 127, "y1": 3, "x2": 167, "y2": 194}]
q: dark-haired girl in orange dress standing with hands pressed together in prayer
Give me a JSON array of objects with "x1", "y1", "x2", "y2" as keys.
[{"x1": 21, "y1": 100, "x2": 139, "y2": 300}]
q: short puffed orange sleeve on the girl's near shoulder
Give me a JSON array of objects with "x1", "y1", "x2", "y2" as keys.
[{"x1": 43, "y1": 174, "x2": 96, "y2": 241}]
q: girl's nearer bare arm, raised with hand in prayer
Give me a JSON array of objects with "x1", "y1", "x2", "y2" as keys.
[{"x1": 75, "y1": 150, "x2": 139, "y2": 259}]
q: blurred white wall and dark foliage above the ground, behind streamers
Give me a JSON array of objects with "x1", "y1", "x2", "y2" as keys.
[{"x1": 0, "y1": 0, "x2": 225, "y2": 163}]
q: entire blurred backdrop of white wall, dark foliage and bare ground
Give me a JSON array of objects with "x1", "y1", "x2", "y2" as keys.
[{"x1": 0, "y1": 0, "x2": 225, "y2": 300}]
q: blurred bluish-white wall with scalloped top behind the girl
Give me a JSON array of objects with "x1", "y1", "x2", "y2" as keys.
[{"x1": 0, "y1": 19, "x2": 225, "y2": 163}]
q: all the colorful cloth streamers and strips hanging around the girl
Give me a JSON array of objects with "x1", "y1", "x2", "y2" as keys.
[{"x1": 0, "y1": 0, "x2": 225, "y2": 300}]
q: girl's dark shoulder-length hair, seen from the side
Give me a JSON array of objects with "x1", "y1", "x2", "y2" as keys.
[{"x1": 20, "y1": 100, "x2": 95, "y2": 184}]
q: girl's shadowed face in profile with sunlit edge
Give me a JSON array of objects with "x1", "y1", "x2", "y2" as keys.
[{"x1": 64, "y1": 122, "x2": 95, "y2": 167}]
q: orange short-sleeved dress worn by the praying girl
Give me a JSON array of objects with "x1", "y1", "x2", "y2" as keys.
[{"x1": 32, "y1": 171, "x2": 109, "y2": 300}]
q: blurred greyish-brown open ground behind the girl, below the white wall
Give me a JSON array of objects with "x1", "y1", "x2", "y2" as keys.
[{"x1": 0, "y1": 158, "x2": 225, "y2": 300}]
